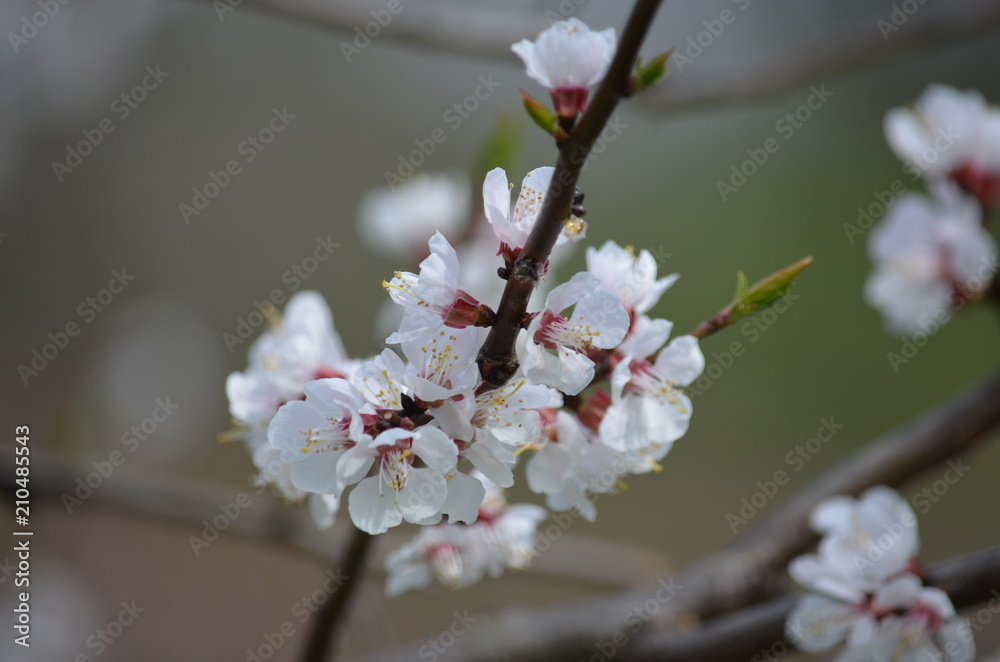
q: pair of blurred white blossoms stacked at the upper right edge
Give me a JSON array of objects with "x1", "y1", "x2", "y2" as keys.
[{"x1": 865, "y1": 85, "x2": 1000, "y2": 334}]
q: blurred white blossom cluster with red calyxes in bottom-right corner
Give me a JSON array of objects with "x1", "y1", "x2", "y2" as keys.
[{"x1": 786, "y1": 486, "x2": 975, "y2": 662}]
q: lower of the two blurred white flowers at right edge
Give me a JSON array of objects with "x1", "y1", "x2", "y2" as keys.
[{"x1": 865, "y1": 185, "x2": 997, "y2": 334}]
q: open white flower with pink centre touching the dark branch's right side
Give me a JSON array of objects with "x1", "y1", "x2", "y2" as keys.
[{"x1": 521, "y1": 271, "x2": 629, "y2": 395}]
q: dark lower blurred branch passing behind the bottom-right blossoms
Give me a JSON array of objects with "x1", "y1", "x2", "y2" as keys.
[{"x1": 621, "y1": 546, "x2": 1000, "y2": 662}]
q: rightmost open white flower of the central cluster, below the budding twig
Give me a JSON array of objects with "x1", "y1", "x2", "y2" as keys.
[{"x1": 599, "y1": 328, "x2": 705, "y2": 457}]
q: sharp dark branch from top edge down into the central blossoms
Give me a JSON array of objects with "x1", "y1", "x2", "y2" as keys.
[{"x1": 478, "y1": 0, "x2": 661, "y2": 387}]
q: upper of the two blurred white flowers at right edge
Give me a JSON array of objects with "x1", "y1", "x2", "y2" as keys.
[{"x1": 884, "y1": 84, "x2": 1000, "y2": 202}]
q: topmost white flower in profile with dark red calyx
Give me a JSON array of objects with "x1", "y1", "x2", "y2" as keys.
[{"x1": 511, "y1": 18, "x2": 615, "y2": 117}]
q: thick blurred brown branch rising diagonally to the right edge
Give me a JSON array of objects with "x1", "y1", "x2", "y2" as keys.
[{"x1": 354, "y1": 373, "x2": 1000, "y2": 662}]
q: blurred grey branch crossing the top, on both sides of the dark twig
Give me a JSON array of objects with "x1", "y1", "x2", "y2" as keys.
[{"x1": 184, "y1": 0, "x2": 1000, "y2": 112}]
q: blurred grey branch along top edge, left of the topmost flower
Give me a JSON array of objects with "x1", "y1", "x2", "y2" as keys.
[{"x1": 188, "y1": 0, "x2": 549, "y2": 61}]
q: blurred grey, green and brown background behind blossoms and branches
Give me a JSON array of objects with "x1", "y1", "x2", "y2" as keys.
[{"x1": 0, "y1": 0, "x2": 1000, "y2": 662}]
